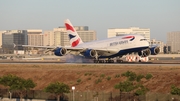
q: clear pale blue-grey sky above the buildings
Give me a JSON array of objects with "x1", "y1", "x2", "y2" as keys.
[{"x1": 0, "y1": 0, "x2": 180, "y2": 43}]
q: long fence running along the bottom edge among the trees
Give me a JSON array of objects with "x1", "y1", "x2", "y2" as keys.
[{"x1": 0, "y1": 89, "x2": 180, "y2": 101}]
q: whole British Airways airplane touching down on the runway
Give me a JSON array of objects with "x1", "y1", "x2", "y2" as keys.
[{"x1": 22, "y1": 19, "x2": 160, "y2": 63}]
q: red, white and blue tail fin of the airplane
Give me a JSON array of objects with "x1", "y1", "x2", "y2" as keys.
[{"x1": 65, "y1": 19, "x2": 83, "y2": 47}]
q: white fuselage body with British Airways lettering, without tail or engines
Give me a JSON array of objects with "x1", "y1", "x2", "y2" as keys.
[{"x1": 76, "y1": 35, "x2": 149, "y2": 56}]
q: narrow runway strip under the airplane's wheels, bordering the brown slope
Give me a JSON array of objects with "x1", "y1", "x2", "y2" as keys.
[{"x1": 0, "y1": 60, "x2": 180, "y2": 66}]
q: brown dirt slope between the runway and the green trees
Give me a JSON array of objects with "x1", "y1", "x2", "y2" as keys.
[{"x1": 0, "y1": 64, "x2": 180, "y2": 93}]
